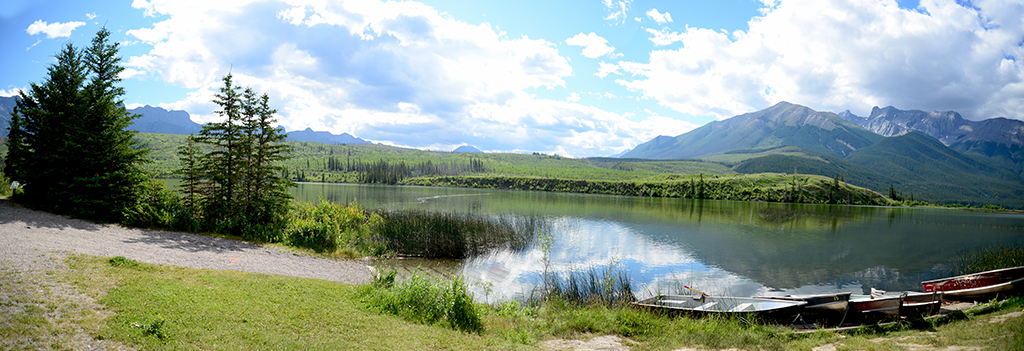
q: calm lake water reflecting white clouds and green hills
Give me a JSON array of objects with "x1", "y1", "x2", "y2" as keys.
[{"x1": 292, "y1": 183, "x2": 1024, "y2": 301}]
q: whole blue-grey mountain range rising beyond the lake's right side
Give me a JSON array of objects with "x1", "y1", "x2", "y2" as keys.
[{"x1": 623, "y1": 102, "x2": 1024, "y2": 208}]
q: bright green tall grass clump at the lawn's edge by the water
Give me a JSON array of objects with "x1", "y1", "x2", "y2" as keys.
[{"x1": 360, "y1": 270, "x2": 483, "y2": 333}]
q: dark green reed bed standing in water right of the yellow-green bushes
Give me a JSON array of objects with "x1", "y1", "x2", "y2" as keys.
[{"x1": 375, "y1": 210, "x2": 547, "y2": 259}]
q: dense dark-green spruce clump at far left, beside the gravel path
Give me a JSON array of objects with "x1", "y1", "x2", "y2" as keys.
[{"x1": 5, "y1": 28, "x2": 146, "y2": 221}]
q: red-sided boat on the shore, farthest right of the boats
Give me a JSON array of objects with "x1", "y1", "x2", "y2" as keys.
[{"x1": 921, "y1": 266, "x2": 1024, "y2": 301}]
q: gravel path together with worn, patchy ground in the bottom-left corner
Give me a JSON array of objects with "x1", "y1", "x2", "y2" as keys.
[{"x1": 0, "y1": 198, "x2": 373, "y2": 350}]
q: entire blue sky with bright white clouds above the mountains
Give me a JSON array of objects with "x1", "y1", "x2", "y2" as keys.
[{"x1": 0, "y1": 0, "x2": 1024, "y2": 157}]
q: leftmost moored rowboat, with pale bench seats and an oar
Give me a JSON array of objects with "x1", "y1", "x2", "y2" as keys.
[{"x1": 633, "y1": 295, "x2": 807, "y2": 320}]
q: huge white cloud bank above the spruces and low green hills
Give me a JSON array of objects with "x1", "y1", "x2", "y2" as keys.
[{"x1": 125, "y1": 0, "x2": 675, "y2": 156}]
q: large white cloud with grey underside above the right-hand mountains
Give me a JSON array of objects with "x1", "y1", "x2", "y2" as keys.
[{"x1": 617, "y1": 0, "x2": 1024, "y2": 120}]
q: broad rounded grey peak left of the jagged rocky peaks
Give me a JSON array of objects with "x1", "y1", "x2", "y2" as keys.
[{"x1": 623, "y1": 101, "x2": 882, "y2": 160}]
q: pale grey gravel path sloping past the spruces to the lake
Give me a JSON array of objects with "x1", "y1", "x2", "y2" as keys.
[{"x1": 0, "y1": 199, "x2": 372, "y2": 283}]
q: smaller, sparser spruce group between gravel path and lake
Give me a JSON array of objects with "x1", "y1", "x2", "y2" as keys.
[{"x1": 178, "y1": 74, "x2": 292, "y2": 242}]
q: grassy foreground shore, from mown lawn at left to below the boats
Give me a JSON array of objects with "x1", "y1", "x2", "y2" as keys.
[{"x1": 25, "y1": 256, "x2": 1024, "y2": 350}]
